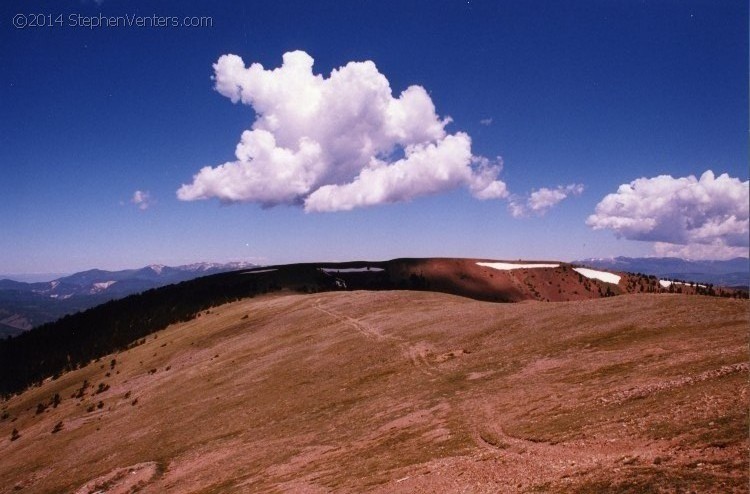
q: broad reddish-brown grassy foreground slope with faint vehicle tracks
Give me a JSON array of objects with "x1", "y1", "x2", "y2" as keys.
[{"x1": 0, "y1": 292, "x2": 750, "y2": 493}]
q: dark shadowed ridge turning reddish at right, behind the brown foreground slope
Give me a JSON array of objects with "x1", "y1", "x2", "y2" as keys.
[{"x1": 0, "y1": 258, "x2": 747, "y2": 396}]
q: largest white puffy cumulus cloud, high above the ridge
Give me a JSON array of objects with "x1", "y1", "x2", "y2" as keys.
[{"x1": 177, "y1": 51, "x2": 508, "y2": 211}]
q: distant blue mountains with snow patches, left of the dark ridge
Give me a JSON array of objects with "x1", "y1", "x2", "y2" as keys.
[{"x1": 0, "y1": 261, "x2": 255, "y2": 337}]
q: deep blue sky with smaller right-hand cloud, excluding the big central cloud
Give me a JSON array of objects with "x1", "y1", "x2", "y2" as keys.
[{"x1": 0, "y1": 0, "x2": 748, "y2": 273}]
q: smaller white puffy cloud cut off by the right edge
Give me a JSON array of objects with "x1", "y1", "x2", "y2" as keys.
[{"x1": 586, "y1": 170, "x2": 750, "y2": 257}]
